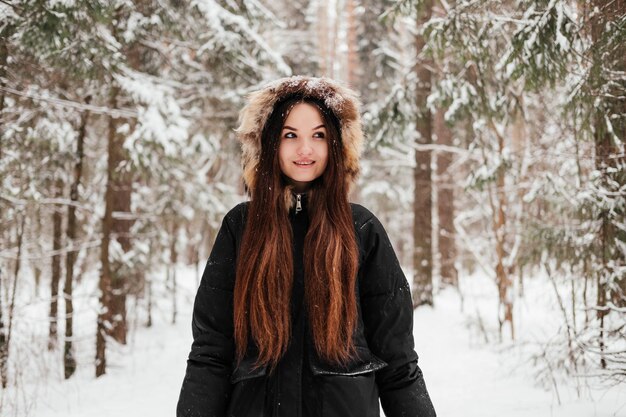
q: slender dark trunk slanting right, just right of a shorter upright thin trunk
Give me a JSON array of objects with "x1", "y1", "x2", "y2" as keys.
[{"x1": 63, "y1": 96, "x2": 91, "y2": 379}]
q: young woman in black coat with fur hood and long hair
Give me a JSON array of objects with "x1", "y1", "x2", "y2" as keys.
[{"x1": 177, "y1": 77, "x2": 435, "y2": 417}]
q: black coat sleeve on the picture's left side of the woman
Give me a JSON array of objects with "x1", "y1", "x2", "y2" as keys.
[{"x1": 176, "y1": 211, "x2": 236, "y2": 417}]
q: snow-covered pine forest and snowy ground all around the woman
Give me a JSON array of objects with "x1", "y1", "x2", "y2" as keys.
[{"x1": 0, "y1": 0, "x2": 626, "y2": 417}]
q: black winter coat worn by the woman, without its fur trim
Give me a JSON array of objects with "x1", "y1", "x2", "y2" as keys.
[{"x1": 177, "y1": 194, "x2": 435, "y2": 417}]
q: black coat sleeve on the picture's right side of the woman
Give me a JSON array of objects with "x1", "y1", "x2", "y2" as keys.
[{"x1": 359, "y1": 216, "x2": 436, "y2": 417}]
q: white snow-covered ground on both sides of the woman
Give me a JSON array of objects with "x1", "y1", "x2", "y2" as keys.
[{"x1": 3, "y1": 271, "x2": 626, "y2": 417}]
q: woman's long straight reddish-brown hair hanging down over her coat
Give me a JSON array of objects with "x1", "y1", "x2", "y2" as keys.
[{"x1": 234, "y1": 95, "x2": 358, "y2": 367}]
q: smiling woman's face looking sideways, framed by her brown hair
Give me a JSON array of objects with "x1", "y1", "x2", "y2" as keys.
[{"x1": 278, "y1": 103, "x2": 328, "y2": 192}]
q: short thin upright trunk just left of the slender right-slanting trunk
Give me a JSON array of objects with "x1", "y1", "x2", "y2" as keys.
[{"x1": 48, "y1": 179, "x2": 63, "y2": 350}]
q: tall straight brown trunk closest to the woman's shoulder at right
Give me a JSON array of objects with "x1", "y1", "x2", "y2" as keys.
[{"x1": 413, "y1": 0, "x2": 433, "y2": 307}]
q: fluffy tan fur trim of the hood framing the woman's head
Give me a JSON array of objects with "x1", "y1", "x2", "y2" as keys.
[{"x1": 236, "y1": 76, "x2": 364, "y2": 207}]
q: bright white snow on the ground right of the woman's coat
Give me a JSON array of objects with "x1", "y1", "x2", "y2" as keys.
[{"x1": 415, "y1": 291, "x2": 626, "y2": 417}]
